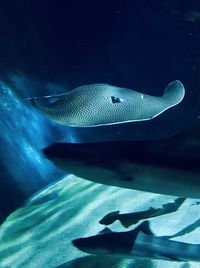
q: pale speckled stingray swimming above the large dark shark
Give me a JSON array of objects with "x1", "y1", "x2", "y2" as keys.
[{"x1": 30, "y1": 81, "x2": 185, "y2": 127}]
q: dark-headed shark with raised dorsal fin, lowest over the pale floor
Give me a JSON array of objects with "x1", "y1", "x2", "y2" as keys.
[{"x1": 72, "y1": 221, "x2": 200, "y2": 262}]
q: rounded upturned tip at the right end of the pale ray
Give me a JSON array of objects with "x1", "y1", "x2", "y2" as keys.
[{"x1": 163, "y1": 80, "x2": 185, "y2": 106}]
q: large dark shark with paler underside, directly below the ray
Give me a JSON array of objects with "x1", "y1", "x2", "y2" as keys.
[{"x1": 44, "y1": 124, "x2": 200, "y2": 198}]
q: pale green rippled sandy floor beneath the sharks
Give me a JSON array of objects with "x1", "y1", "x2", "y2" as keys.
[{"x1": 0, "y1": 175, "x2": 200, "y2": 268}]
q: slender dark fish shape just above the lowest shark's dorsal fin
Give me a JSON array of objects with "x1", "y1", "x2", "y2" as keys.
[{"x1": 99, "y1": 198, "x2": 185, "y2": 228}]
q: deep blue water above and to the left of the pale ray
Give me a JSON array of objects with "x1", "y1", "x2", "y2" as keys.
[{"x1": 0, "y1": 0, "x2": 200, "y2": 258}]
